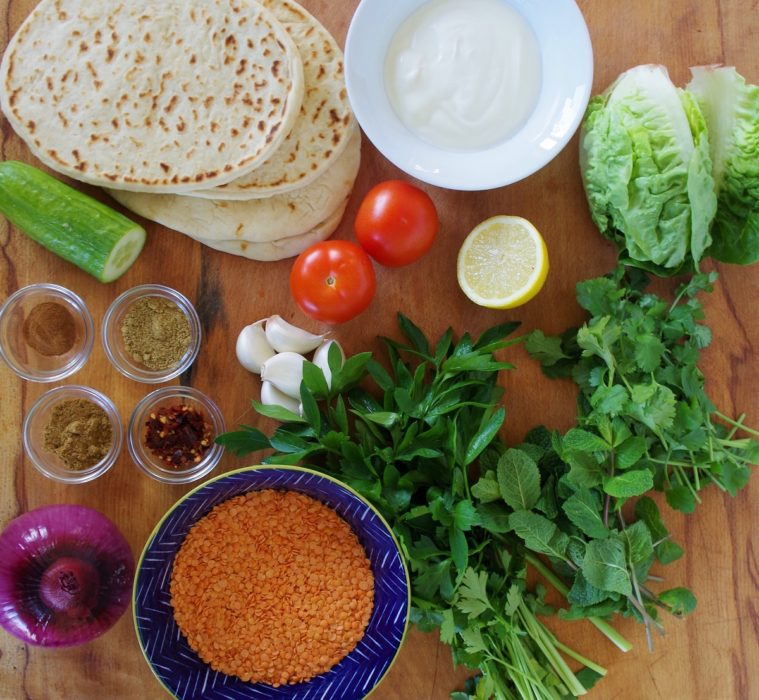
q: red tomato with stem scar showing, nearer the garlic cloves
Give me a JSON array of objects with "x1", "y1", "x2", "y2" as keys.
[{"x1": 290, "y1": 241, "x2": 377, "y2": 323}]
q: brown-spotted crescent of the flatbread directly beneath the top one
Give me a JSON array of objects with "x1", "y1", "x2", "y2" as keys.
[{"x1": 191, "y1": 0, "x2": 355, "y2": 199}]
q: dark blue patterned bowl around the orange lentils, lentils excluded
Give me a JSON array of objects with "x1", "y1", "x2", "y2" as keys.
[{"x1": 133, "y1": 466, "x2": 410, "y2": 700}]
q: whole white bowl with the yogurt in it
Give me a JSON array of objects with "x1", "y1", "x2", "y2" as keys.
[{"x1": 345, "y1": 0, "x2": 593, "y2": 190}]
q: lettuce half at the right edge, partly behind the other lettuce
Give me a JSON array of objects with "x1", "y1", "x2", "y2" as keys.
[{"x1": 686, "y1": 66, "x2": 759, "y2": 265}]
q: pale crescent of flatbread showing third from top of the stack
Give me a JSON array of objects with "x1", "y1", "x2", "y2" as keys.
[{"x1": 109, "y1": 128, "x2": 361, "y2": 243}]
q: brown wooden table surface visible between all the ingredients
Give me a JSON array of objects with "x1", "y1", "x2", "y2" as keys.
[{"x1": 0, "y1": 0, "x2": 759, "y2": 700}]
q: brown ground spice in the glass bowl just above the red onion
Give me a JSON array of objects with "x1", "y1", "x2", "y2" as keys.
[{"x1": 43, "y1": 399, "x2": 112, "y2": 471}]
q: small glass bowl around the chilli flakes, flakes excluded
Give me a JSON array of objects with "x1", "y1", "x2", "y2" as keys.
[{"x1": 127, "y1": 386, "x2": 224, "y2": 484}]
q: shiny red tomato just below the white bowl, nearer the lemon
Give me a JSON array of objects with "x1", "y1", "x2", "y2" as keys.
[{"x1": 355, "y1": 180, "x2": 440, "y2": 267}]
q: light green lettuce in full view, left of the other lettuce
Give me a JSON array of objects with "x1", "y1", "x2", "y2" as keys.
[{"x1": 580, "y1": 65, "x2": 717, "y2": 274}]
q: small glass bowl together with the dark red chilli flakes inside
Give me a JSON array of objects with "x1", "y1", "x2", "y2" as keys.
[{"x1": 127, "y1": 386, "x2": 224, "y2": 484}]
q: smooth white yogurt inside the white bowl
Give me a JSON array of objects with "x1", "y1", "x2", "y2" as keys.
[{"x1": 384, "y1": 0, "x2": 541, "y2": 150}]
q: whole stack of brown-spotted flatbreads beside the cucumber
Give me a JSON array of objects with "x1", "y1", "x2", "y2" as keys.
[{"x1": 0, "y1": 0, "x2": 361, "y2": 260}]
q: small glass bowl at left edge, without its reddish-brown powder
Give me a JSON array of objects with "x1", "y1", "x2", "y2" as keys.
[{"x1": 0, "y1": 283, "x2": 95, "y2": 382}]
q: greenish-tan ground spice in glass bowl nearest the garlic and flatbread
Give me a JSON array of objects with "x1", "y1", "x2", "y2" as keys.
[{"x1": 121, "y1": 296, "x2": 192, "y2": 372}]
